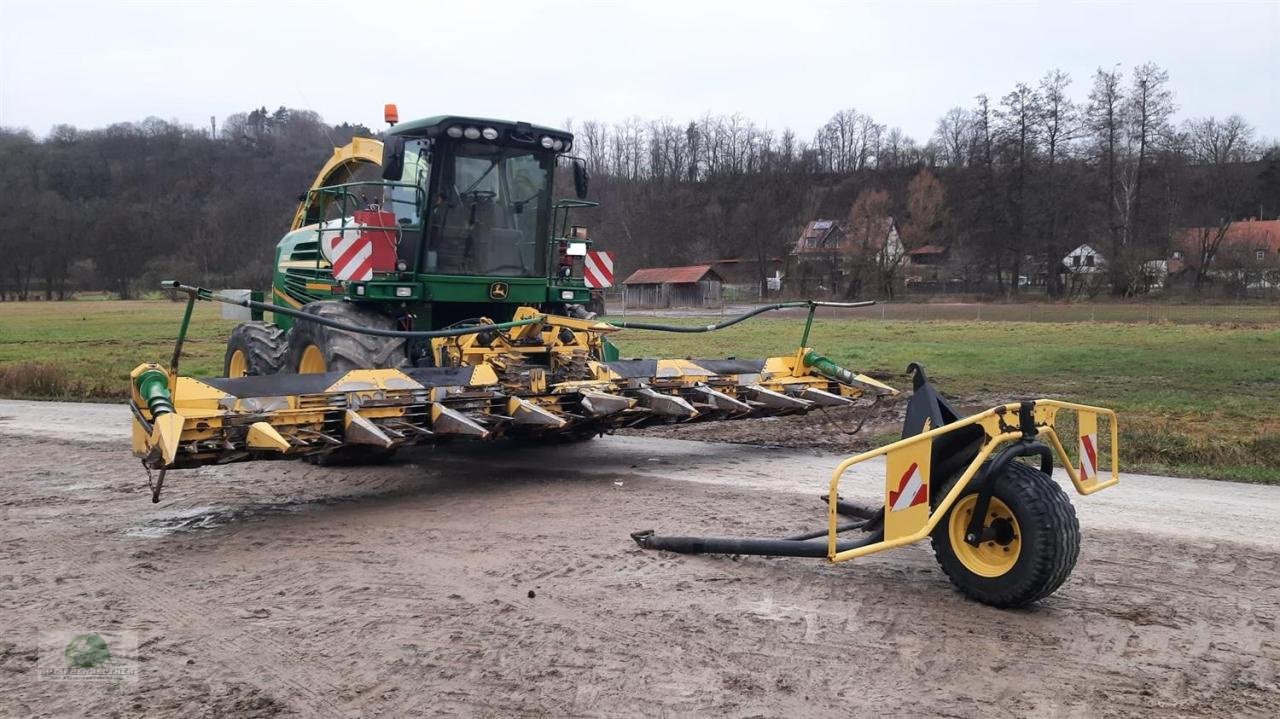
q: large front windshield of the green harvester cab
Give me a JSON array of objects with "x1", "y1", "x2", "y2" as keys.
[{"x1": 425, "y1": 143, "x2": 550, "y2": 278}]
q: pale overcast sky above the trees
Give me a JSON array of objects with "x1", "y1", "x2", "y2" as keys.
[{"x1": 0, "y1": 0, "x2": 1280, "y2": 141}]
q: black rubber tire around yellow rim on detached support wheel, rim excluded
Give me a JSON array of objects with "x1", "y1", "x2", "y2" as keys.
[{"x1": 932, "y1": 462, "x2": 1080, "y2": 608}]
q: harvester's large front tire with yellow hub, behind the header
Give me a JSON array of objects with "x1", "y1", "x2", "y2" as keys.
[{"x1": 288, "y1": 299, "x2": 407, "y2": 374}]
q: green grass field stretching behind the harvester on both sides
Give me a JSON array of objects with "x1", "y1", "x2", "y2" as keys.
[{"x1": 0, "y1": 296, "x2": 1280, "y2": 482}]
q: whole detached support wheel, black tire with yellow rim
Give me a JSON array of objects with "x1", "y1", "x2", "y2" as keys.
[{"x1": 932, "y1": 462, "x2": 1080, "y2": 608}]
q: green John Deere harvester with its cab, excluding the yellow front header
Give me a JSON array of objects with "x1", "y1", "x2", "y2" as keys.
[{"x1": 264, "y1": 115, "x2": 594, "y2": 375}]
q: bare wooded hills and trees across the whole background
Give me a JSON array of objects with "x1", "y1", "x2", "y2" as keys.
[{"x1": 0, "y1": 64, "x2": 1280, "y2": 301}]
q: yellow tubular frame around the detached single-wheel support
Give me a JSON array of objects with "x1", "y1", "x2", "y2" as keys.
[{"x1": 827, "y1": 399, "x2": 1120, "y2": 562}]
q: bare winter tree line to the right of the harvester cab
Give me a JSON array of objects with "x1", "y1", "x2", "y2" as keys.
[{"x1": 573, "y1": 64, "x2": 1280, "y2": 297}]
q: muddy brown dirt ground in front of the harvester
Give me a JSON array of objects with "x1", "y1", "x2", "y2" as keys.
[{"x1": 0, "y1": 403, "x2": 1280, "y2": 718}]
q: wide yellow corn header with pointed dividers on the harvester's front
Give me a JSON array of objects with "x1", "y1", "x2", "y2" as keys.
[{"x1": 131, "y1": 283, "x2": 896, "y2": 470}]
